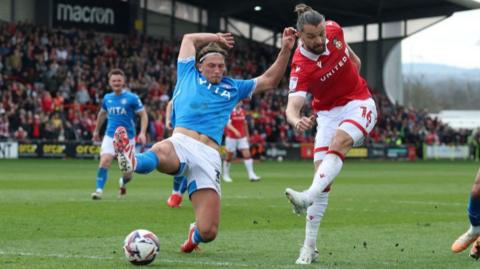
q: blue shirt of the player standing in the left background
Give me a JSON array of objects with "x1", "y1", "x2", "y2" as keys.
[{"x1": 102, "y1": 89, "x2": 144, "y2": 139}]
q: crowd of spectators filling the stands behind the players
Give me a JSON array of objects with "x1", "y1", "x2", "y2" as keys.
[{"x1": 0, "y1": 23, "x2": 480, "y2": 152}]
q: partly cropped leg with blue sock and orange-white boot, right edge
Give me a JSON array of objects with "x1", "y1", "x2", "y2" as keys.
[{"x1": 452, "y1": 170, "x2": 480, "y2": 253}]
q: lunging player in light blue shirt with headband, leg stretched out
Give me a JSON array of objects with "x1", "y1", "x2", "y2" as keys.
[{"x1": 114, "y1": 28, "x2": 295, "y2": 253}]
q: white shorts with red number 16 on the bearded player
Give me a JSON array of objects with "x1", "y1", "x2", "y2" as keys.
[{"x1": 313, "y1": 98, "x2": 377, "y2": 162}]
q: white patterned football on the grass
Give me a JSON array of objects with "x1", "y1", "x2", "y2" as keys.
[{"x1": 123, "y1": 229, "x2": 160, "y2": 265}]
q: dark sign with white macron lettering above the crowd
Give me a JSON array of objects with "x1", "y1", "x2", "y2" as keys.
[{"x1": 52, "y1": 0, "x2": 129, "y2": 33}]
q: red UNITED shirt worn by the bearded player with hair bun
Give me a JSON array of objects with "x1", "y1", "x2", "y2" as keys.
[{"x1": 289, "y1": 21, "x2": 370, "y2": 111}]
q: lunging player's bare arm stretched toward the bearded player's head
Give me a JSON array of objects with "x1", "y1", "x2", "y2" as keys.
[{"x1": 254, "y1": 27, "x2": 296, "y2": 93}]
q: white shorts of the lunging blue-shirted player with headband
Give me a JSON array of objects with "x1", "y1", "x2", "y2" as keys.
[{"x1": 168, "y1": 133, "x2": 222, "y2": 196}]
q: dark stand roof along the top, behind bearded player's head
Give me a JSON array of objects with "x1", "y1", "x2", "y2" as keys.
[{"x1": 179, "y1": 0, "x2": 480, "y2": 32}]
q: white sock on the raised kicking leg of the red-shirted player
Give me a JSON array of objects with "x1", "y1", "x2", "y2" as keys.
[{"x1": 307, "y1": 153, "x2": 343, "y2": 197}]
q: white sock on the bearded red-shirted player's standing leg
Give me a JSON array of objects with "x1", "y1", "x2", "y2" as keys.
[{"x1": 303, "y1": 192, "x2": 329, "y2": 249}]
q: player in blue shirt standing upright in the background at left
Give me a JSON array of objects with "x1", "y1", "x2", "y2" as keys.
[{"x1": 91, "y1": 69, "x2": 148, "y2": 200}]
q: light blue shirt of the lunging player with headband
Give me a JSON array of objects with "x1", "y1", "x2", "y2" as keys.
[{"x1": 171, "y1": 57, "x2": 257, "y2": 144}]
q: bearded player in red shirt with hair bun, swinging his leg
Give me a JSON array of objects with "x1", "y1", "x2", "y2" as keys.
[{"x1": 285, "y1": 4, "x2": 377, "y2": 264}]
